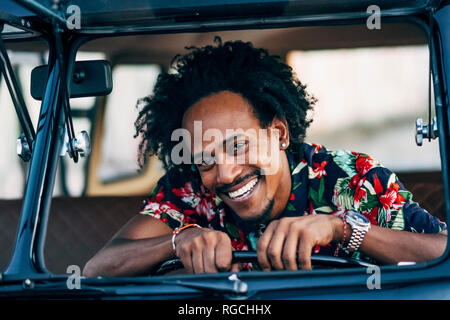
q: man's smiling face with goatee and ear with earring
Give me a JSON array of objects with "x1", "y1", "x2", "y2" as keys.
[{"x1": 182, "y1": 91, "x2": 291, "y2": 223}]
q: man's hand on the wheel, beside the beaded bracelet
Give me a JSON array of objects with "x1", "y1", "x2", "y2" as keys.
[{"x1": 175, "y1": 228, "x2": 237, "y2": 273}]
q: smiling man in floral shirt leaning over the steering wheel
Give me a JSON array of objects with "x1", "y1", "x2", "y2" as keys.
[{"x1": 84, "y1": 41, "x2": 447, "y2": 276}]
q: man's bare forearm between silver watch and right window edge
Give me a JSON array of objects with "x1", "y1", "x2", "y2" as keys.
[{"x1": 356, "y1": 226, "x2": 447, "y2": 264}]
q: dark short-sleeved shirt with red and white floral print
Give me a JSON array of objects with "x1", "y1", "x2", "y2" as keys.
[{"x1": 140, "y1": 143, "x2": 447, "y2": 269}]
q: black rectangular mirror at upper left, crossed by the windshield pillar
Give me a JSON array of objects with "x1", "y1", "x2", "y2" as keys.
[{"x1": 30, "y1": 60, "x2": 113, "y2": 100}]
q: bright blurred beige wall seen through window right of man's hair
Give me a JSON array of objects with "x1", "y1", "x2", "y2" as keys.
[{"x1": 287, "y1": 46, "x2": 440, "y2": 171}]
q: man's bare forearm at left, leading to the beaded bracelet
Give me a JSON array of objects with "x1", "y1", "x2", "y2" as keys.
[{"x1": 83, "y1": 234, "x2": 175, "y2": 277}]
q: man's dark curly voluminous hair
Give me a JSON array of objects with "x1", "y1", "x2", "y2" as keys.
[{"x1": 135, "y1": 37, "x2": 316, "y2": 188}]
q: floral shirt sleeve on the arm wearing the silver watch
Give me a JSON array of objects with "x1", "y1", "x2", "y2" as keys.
[{"x1": 333, "y1": 150, "x2": 447, "y2": 233}]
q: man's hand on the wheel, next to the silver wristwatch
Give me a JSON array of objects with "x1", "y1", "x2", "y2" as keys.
[{"x1": 257, "y1": 214, "x2": 342, "y2": 271}]
